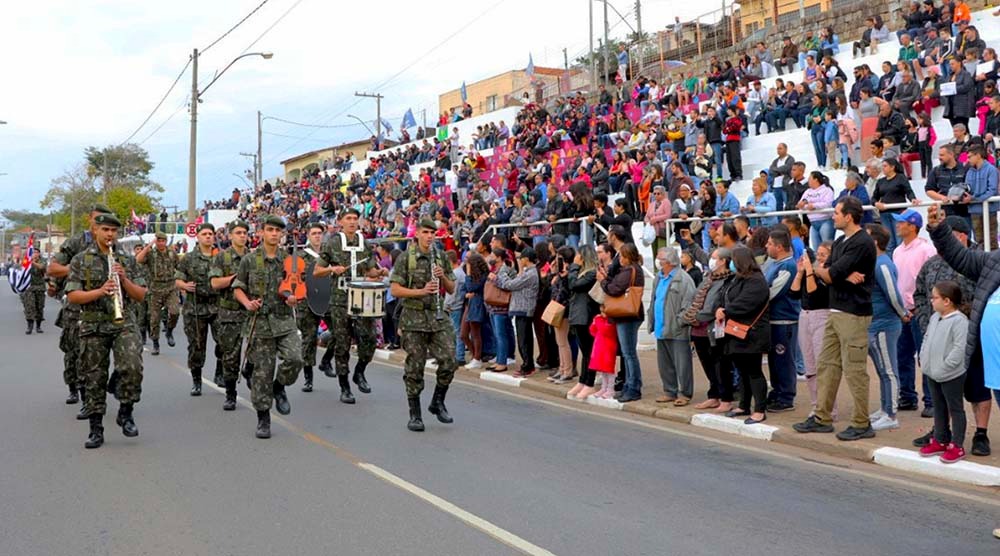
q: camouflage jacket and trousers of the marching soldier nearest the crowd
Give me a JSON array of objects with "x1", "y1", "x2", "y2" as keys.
[{"x1": 389, "y1": 242, "x2": 458, "y2": 398}]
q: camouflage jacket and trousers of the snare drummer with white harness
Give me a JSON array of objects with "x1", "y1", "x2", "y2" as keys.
[{"x1": 316, "y1": 233, "x2": 377, "y2": 376}]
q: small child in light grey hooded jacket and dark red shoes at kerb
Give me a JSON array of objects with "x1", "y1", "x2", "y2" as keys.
[{"x1": 920, "y1": 280, "x2": 969, "y2": 463}]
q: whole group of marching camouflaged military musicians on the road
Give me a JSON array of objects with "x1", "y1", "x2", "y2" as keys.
[{"x1": 31, "y1": 204, "x2": 457, "y2": 448}]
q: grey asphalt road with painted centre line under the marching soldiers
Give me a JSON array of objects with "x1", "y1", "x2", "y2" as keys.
[{"x1": 0, "y1": 289, "x2": 1000, "y2": 556}]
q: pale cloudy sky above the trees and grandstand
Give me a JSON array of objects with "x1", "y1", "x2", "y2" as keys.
[{"x1": 0, "y1": 0, "x2": 721, "y2": 217}]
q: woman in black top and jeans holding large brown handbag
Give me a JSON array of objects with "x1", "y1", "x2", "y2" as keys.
[{"x1": 597, "y1": 243, "x2": 645, "y2": 403}]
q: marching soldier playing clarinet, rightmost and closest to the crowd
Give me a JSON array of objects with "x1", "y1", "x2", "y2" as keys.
[{"x1": 389, "y1": 218, "x2": 457, "y2": 431}]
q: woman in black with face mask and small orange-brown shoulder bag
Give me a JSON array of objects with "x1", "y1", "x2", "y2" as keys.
[{"x1": 715, "y1": 247, "x2": 771, "y2": 425}]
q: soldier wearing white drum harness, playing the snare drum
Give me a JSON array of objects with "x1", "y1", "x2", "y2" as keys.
[{"x1": 313, "y1": 208, "x2": 386, "y2": 404}]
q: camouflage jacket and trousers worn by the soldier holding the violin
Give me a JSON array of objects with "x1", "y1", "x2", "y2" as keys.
[{"x1": 232, "y1": 246, "x2": 308, "y2": 412}]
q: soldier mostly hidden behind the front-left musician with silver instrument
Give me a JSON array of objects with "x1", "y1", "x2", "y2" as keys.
[{"x1": 48, "y1": 204, "x2": 111, "y2": 412}]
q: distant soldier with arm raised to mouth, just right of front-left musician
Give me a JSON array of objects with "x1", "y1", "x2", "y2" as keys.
[{"x1": 135, "y1": 232, "x2": 180, "y2": 355}]
